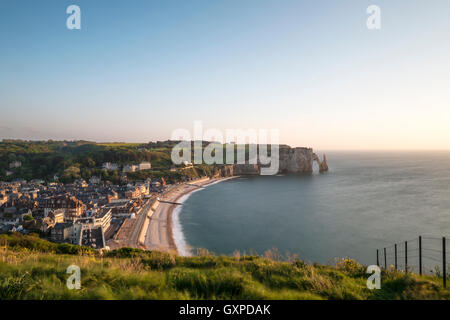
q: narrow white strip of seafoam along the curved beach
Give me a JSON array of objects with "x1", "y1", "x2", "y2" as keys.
[{"x1": 172, "y1": 176, "x2": 238, "y2": 256}]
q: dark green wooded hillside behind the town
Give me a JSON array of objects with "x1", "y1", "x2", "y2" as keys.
[{"x1": 0, "y1": 140, "x2": 218, "y2": 183}]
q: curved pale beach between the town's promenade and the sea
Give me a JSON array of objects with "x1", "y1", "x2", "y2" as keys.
[{"x1": 145, "y1": 176, "x2": 239, "y2": 256}]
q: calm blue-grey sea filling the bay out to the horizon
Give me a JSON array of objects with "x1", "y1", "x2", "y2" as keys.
[{"x1": 178, "y1": 152, "x2": 450, "y2": 264}]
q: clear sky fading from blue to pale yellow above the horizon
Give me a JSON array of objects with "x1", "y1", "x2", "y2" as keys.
[{"x1": 0, "y1": 0, "x2": 450, "y2": 150}]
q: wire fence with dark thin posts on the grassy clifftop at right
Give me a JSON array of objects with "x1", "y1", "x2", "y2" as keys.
[{"x1": 377, "y1": 236, "x2": 450, "y2": 288}]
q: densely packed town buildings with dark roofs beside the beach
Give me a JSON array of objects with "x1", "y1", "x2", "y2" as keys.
[{"x1": 0, "y1": 161, "x2": 168, "y2": 249}]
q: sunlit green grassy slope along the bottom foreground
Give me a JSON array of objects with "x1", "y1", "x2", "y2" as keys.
[{"x1": 0, "y1": 234, "x2": 450, "y2": 300}]
